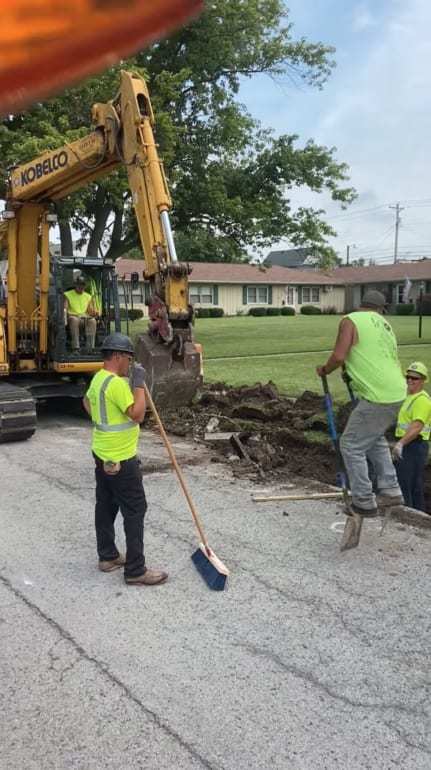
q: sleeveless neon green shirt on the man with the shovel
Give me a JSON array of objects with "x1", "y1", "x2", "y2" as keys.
[{"x1": 345, "y1": 310, "x2": 406, "y2": 404}]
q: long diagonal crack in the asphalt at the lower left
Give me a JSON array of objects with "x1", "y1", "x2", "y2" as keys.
[{"x1": 0, "y1": 573, "x2": 222, "y2": 770}]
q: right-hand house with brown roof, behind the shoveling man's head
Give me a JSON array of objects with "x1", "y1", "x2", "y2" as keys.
[{"x1": 327, "y1": 259, "x2": 431, "y2": 312}]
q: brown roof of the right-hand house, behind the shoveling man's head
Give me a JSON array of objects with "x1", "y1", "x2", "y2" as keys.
[{"x1": 326, "y1": 259, "x2": 431, "y2": 284}]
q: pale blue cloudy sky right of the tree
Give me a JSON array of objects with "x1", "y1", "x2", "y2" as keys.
[{"x1": 239, "y1": 0, "x2": 431, "y2": 264}]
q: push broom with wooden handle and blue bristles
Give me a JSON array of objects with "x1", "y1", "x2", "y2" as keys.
[{"x1": 144, "y1": 385, "x2": 229, "y2": 591}]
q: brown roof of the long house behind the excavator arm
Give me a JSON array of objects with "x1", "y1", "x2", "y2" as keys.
[{"x1": 115, "y1": 258, "x2": 341, "y2": 286}]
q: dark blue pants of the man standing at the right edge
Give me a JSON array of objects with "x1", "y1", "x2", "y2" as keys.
[{"x1": 394, "y1": 438, "x2": 428, "y2": 511}]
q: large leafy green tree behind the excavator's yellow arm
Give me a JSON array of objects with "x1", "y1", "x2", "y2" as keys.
[{"x1": 0, "y1": 0, "x2": 354, "y2": 263}]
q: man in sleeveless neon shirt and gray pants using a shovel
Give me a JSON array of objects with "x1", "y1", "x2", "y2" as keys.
[{"x1": 317, "y1": 290, "x2": 406, "y2": 516}]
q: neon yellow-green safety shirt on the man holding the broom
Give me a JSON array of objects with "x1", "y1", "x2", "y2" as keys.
[{"x1": 86, "y1": 369, "x2": 139, "y2": 462}]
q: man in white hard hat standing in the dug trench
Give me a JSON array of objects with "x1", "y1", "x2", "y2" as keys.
[{"x1": 392, "y1": 361, "x2": 431, "y2": 511}]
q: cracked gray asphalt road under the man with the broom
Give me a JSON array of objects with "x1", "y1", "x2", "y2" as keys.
[{"x1": 0, "y1": 404, "x2": 431, "y2": 770}]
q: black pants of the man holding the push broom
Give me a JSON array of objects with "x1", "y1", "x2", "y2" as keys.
[{"x1": 94, "y1": 457, "x2": 147, "y2": 577}]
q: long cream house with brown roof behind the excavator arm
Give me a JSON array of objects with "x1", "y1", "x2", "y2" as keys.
[{"x1": 116, "y1": 258, "x2": 344, "y2": 315}]
